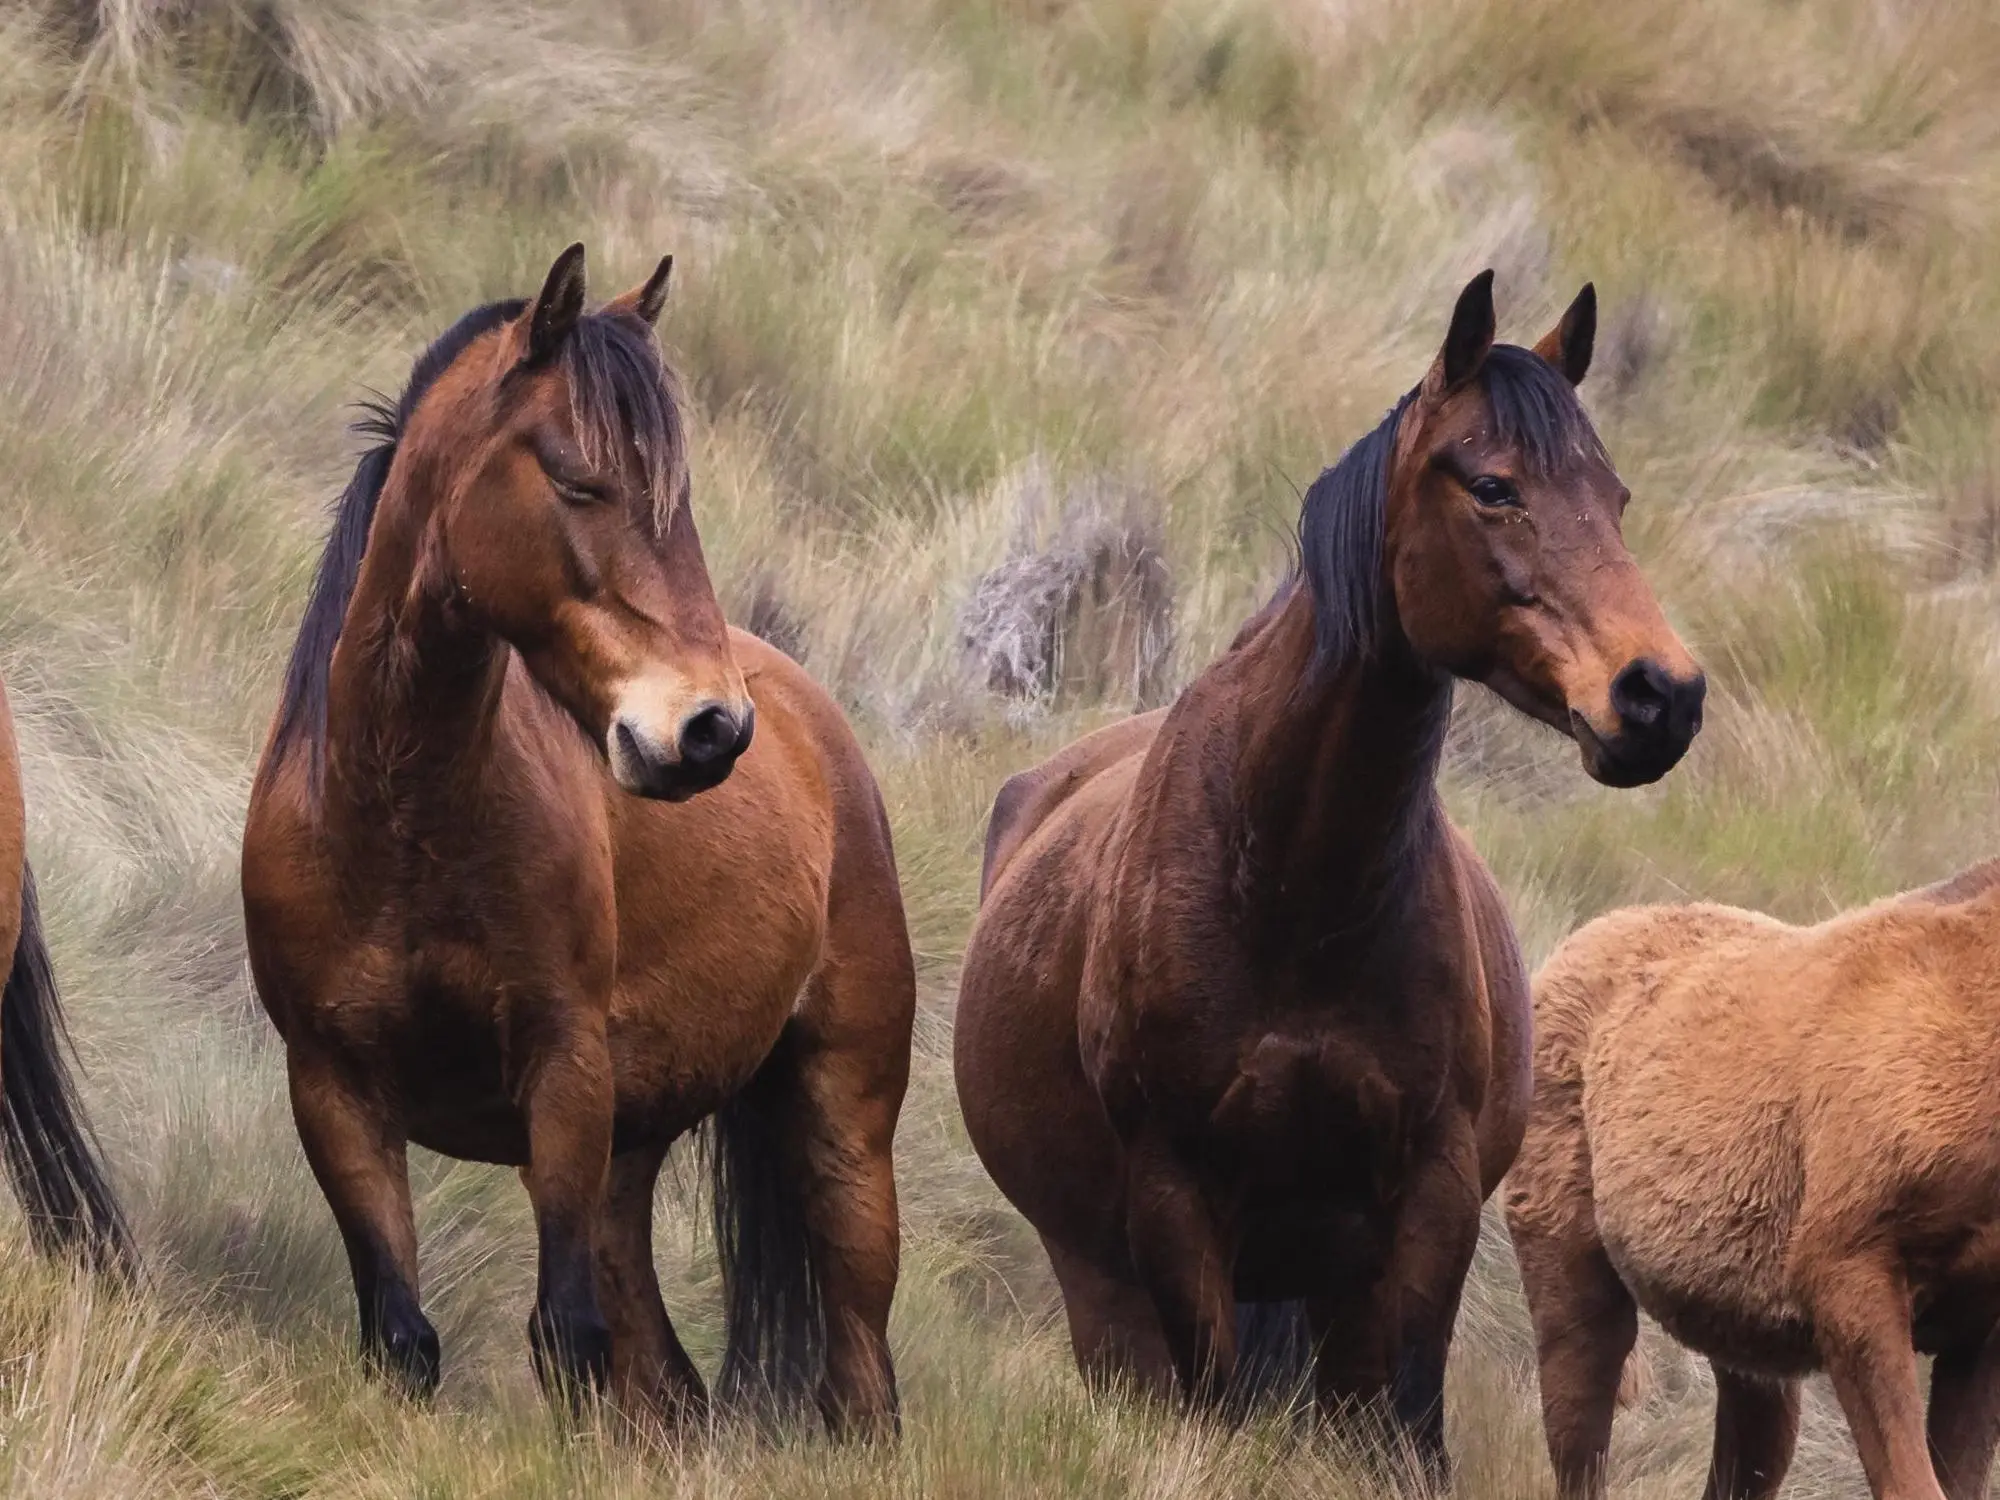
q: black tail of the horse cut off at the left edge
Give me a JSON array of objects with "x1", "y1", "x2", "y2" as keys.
[{"x1": 0, "y1": 868, "x2": 138, "y2": 1272}]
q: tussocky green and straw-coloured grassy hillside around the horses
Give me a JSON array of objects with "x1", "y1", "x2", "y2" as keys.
[{"x1": 0, "y1": 0, "x2": 2000, "y2": 1500}]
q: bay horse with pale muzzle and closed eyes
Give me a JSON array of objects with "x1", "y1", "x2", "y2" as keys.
[{"x1": 242, "y1": 246, "x2": 916, "y2": 1434}]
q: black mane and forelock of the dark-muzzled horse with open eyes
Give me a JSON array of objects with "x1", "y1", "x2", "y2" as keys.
[{"x1": 1294, "y1": 344, "x2": 1604, "y2": 674}]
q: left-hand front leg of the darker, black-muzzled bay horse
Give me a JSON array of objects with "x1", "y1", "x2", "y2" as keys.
[{"x1": 1126, "y1": 1126, "x2": 1236, "y2": 1410}]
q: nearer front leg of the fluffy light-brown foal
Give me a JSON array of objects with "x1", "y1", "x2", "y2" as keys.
[{"x1": 1798, "y1": 1248, "x2": 1944, "y2": 1500}]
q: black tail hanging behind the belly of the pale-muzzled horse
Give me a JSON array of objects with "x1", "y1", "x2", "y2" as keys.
[{"x1": 710, "y1": 1038, "x2": 826, "y2": 1422}]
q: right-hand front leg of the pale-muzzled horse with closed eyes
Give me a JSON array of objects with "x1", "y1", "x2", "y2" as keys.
[{"x1": 522, "y1": 1006, "x2": 614, "y2": 1396}]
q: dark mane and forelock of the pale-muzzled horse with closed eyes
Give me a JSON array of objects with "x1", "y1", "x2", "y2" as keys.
[{"x1": 268, "y1": 300, "x2": 688, "y2": 798}]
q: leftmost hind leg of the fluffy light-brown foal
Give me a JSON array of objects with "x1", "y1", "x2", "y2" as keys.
[{"x1": 1514, "y1": 1222, "x2": 1638, "y2": 1500}]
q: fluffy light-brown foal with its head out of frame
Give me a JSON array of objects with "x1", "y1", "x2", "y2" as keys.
[{"x1": 1506, "y1": 860, "x2": 2000, "y2": 1500}]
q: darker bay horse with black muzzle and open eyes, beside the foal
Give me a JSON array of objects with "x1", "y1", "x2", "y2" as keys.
[{"x1": 956, "y1": 272, "x2": 1704, "y2": 1474}]
